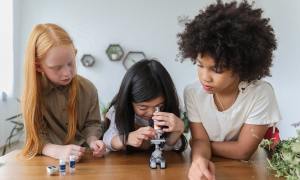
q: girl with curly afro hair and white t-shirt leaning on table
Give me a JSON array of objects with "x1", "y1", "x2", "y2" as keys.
[{"x1": 178, "y1": 1, "x2": 281, "y2": 179}]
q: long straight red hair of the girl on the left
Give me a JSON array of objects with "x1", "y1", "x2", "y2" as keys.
[{"x1": 21, "y1": 24, "x2": 78, "y2": 158}]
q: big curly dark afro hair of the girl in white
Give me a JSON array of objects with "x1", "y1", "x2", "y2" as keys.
[{"x1": 177, "y1": 0, "x2": 277, "y2": 82}]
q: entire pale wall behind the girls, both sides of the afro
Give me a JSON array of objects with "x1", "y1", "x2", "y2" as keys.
[{"x1": 15, "y1": 0, "x2": 300, "y2": 138}]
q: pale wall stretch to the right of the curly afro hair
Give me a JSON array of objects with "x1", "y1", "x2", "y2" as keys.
[{"x1": 257, "y1": 0, "x2": 300, "y2": 137}]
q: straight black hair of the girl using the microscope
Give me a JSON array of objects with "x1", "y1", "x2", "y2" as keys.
[{"x1": 110, "y1": 59, "x2": 180, "y2": 144}]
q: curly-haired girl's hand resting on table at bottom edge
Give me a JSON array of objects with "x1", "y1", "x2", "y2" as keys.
[{"x1": 188, "y1": 157, "x2": 216, "y2": 180}]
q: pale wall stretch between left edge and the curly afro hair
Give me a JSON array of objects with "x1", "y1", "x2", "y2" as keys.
[{"x1": 13, "y1": 0, "x2": 209, "y2": 102}]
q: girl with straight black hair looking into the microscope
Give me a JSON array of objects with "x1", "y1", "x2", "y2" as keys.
[{"x1": 103, "y1": 59, "x2": 187, "y2": 152}]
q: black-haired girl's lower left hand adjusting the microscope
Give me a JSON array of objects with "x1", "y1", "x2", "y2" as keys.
[{"x1": 127, "y1": 126, "x2": 155, "y2": 147}]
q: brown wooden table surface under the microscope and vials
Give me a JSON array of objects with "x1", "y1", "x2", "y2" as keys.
[{"x1": 0, "y1": 149, "x2": 279, "y2": 180}]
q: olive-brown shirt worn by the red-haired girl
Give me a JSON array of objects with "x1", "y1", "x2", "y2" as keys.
[{"x1": 41, "y1": 75, "x2": 102, "y2": 146}]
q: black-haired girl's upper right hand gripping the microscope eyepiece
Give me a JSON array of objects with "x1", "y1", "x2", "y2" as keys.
[{"x1": 152, "y1": 112, "x2": 184, "y2": 133}]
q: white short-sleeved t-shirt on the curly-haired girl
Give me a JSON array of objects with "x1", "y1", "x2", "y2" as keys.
[{"x1": 184, "y1": 80, "x2": 281, "y2": 141}]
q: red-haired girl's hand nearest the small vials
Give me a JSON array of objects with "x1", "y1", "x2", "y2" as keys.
[{"x1": 56, "y1": 144, "x2": 85, "y2": 162}]
